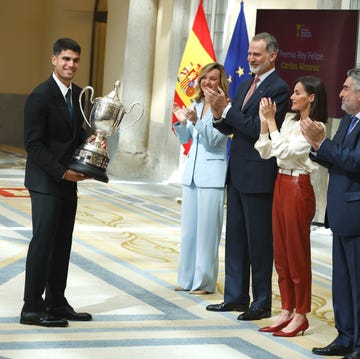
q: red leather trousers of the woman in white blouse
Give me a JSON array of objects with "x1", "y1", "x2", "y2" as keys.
[{"x1": 272, "y1": 173, "x2": 315, "y2": 314}]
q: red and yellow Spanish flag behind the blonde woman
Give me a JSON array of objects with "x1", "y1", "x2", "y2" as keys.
[{"x1": 172, "y1": 0, "x2": 216, "y2": 155}]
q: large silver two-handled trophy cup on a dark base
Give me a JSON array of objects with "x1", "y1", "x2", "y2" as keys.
[{"x1": 69, "y1": 81, "x2": 144, "y2": 183}]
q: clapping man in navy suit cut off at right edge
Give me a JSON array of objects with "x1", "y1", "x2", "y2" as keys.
[{"x1": 301, "y1": 68, "x2": 360, "y2": 359}]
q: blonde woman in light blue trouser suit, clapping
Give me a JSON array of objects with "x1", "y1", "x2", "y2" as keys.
[{"x1": 173, "y1": 63, "x2": 227, "y2": 294}]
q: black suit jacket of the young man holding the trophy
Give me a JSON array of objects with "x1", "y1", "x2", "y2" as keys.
[{"x1": 24, "y1": 76, "x2": 86, "y2": 195}]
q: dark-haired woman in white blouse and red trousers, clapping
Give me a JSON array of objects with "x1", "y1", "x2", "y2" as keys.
[{"x1": 255, "y1": 76, "x2": 328, "y2": 337}]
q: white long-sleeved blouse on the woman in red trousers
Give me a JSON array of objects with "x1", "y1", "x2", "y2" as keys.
[{"x1": 254, "y1": 116, "x2": 325, "y2": 173}]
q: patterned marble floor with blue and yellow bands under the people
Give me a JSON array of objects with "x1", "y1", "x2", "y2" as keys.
[{"x1": 0, "y1": 145, "x2": 336, "y2": 359}]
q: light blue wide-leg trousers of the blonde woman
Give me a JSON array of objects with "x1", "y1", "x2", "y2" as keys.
[{"x1": 178, "y1": 184, "x2": 225, "y2": 293}]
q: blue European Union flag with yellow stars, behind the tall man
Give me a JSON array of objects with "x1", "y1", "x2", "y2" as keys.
[{"x1": 224, "y1": 1, "x2": 251, "y2": 100}]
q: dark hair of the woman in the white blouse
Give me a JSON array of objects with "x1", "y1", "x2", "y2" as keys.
[{"x1": 294, "y1": 76, "x2": 328, "y2": 123}]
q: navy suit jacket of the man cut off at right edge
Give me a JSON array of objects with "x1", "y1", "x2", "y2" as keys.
[{"x1": 312, "y1": 115, "x2": 360, "y2": 236}]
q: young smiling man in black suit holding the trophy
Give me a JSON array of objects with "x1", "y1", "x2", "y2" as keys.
[{"x1": 20, "y1": 38, "x2": 99, "y2": 327}]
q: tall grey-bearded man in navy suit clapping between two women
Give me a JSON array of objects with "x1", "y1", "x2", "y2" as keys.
[{"x1": 205, "y1": 33, "x2": 289, "y2": 320}]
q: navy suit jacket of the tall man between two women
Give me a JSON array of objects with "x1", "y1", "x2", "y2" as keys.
[{"x1": 215, "y1": 71, "x2": 289, "y2": 193}]
